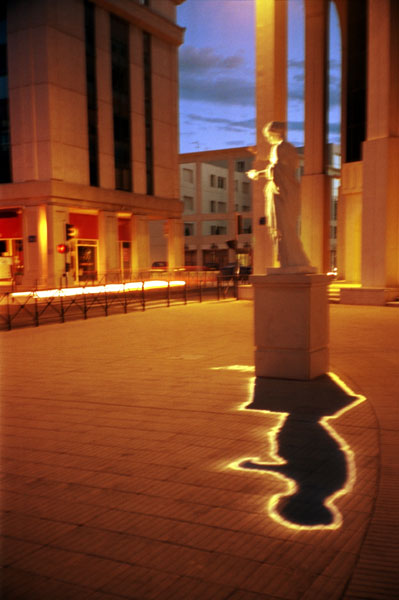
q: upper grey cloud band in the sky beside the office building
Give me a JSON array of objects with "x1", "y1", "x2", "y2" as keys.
[{"x1": 179, "y1": 46, "x2": 245, "y2": 75}]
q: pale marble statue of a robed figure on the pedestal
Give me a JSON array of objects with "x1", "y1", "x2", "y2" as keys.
[{"x1": 247, "y1": 121, "x2": 316, "y2": 273}]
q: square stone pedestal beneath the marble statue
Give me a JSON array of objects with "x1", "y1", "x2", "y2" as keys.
[{"x1": 251, "y1": 273, "x2": 330, "y2": 380}]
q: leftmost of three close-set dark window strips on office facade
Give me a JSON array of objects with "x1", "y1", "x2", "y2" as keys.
[{"x1": 85, "y1": 0, "x2": 99, "y2": 186}]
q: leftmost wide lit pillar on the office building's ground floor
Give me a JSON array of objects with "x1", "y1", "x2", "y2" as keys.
[{"x1": 22, "y1": 206, "x2": 47, "y2": 289}]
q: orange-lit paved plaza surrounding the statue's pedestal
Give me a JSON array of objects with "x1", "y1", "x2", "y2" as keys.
[{"x1": 0, "y1": 300, "x2": 399, "y2": 600}]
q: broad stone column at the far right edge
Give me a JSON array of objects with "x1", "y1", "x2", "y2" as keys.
[{"x1": 362, "y1": 0, "x2": 399, "y2": 288}]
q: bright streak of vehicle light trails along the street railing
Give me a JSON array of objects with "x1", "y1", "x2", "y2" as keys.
[{"x1": 11, "y1": 280, "x2": 186, "y2": 299}]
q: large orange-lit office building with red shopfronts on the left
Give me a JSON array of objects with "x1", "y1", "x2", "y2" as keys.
[{"x1": 0, "y1": 0, "x2": 184, "y2": 288}]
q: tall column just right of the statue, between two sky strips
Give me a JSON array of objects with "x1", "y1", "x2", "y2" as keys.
[{"x1": 301, "y1": 0, "x2": 330, "y2": 273}]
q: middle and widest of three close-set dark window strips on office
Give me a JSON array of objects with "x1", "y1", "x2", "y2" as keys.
[{"x1": 111, "y1": 15, "x2": 132, "y2": 191}]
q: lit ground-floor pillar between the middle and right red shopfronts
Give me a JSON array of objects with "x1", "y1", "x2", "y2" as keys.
[{"x1": 98, "y1": 211, "x2": 120, "y2": 283}]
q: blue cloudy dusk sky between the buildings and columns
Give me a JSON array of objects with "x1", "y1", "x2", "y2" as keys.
[{"x1": 177, "y1": 0, "x2": 340, "y2": 152}]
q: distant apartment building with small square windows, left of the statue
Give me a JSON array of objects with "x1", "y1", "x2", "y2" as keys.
[{"x1": 179, "y1": 147, "x2": 254, "y2": 268}]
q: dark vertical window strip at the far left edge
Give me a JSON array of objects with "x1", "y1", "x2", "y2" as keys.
[{"x1": 0, "y1": 3, "x2": 12, "y2": 183}]
